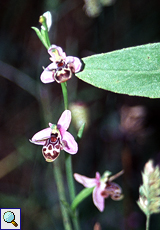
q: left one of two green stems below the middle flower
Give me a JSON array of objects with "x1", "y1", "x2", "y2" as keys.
[{"x1": 53, "y1": 159, "x2": 72, "y2": 230}]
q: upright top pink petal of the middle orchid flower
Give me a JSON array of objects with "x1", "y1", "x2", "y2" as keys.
[{"x1": 57, "y1": 110, "x2": 71, "y2": 130}]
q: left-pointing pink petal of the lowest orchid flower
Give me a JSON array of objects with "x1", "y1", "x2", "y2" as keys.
[{"x1": 74, "y1": 173, "x2": 96, "y2": 188}]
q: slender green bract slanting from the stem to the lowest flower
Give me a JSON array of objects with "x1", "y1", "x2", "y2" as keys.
[{"x1": 71, "y1": 187, "x2": 94, "y2": 210}]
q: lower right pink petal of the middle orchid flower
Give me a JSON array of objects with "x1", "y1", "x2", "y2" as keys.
[{"x1": 62, "y1": 131, "x2": 78, "y2": 154}]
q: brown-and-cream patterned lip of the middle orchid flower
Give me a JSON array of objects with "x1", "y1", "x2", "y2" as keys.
[{"x1": 42, "y1": 133, "x2": 63, "y2": 162}]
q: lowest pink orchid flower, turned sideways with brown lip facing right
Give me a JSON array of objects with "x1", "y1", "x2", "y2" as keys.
[{"x1": 74, "y1": 170, "x2": 123, "y2": 212}]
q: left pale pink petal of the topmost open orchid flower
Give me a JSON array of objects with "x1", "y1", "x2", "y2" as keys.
[{"x1": 40, "y1": 63, "x2": 57, "y2": 83}]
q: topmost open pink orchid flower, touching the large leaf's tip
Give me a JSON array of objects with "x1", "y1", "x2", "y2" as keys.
[{"x1": 40, "y1": 45, "x2": 82, "y2": 83}]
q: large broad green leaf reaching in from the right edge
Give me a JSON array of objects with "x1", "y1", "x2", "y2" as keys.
[{"x1": 76, "y1": 43, "x2": 160, "y2": 98}]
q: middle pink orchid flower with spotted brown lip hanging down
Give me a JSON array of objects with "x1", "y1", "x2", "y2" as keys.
[{"x1": 30, "y1": 110, "x2": 78, "y2": 162}]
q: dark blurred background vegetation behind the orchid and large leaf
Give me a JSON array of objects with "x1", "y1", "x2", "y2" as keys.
[{"x1": 0, "y1": 0, "x2": 160, "y2": 230}]
